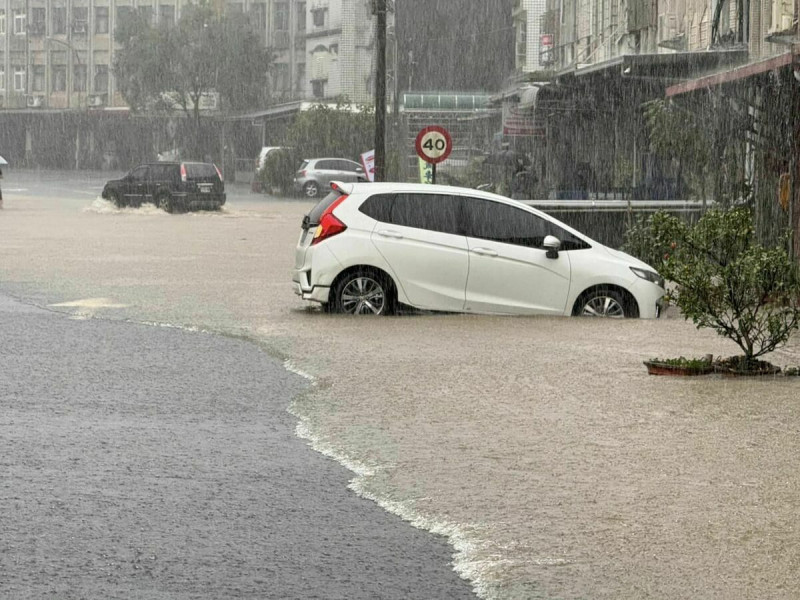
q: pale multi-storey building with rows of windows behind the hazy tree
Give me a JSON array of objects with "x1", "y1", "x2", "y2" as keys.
[{"x1": 0, "y1": 0, "x2": 374, "y2": 111}]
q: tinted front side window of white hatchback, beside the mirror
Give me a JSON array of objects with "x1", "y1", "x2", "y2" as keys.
[{"x1": 466, "y1": 198, "x2": 589, "y2": 250}]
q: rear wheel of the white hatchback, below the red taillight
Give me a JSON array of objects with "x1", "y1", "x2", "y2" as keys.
[{"x1": 329, "y1": 269, "x2": 396, "y2": 315}]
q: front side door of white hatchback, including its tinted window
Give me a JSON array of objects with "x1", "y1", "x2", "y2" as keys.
[{"x1": 464, "y1": 198, "x2": 570, "y2": 315}]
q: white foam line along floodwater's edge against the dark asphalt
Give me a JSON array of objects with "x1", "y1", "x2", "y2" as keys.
[{"x1": 283, "y1": 360, "x2": 496, "y2": 599}]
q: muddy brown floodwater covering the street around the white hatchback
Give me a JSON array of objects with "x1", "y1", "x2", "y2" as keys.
[{"x1": 0, "y1": 171, "x2": 800, "y2": 599}]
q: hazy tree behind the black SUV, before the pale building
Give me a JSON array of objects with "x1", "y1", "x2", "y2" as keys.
[{"x1": 113, "y1": 3, "x2": 272, "y2": 152}]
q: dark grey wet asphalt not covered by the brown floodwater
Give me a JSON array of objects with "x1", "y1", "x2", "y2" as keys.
[{"x1": 0, "y1": 295, "x2": 473, "y2": 599}]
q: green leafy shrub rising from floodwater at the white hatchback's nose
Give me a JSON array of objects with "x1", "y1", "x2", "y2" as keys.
[{"x1": 625, "y1": 206, "x2": 800, "y2": 367}]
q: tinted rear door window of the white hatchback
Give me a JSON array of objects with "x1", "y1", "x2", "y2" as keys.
[{"x1": 390, "y1": 193, "x2": 465, "y2": 235}]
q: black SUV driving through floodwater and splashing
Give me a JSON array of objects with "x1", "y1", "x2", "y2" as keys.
[{"x1": 102, "y1": 162, "x2": 225, "y2": 212}]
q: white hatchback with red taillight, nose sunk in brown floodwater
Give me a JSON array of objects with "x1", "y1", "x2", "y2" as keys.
[{"x1": 293, "y1": 182, "x2": 665, "y2": 318}]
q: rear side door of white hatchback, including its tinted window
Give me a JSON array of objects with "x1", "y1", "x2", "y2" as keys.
[{"x1": 371, "y1": 193, "x2": 469, "y2": 311}]
